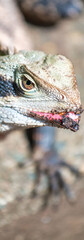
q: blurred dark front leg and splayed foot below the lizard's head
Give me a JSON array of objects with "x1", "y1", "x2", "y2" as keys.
[{"x1": 26, "y1": 127, "x2": 80, "y2": 206}]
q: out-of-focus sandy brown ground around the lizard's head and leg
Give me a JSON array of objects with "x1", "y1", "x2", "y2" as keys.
[{"x1": 0, "y1": 4, "x2": 84, "y2": 240}]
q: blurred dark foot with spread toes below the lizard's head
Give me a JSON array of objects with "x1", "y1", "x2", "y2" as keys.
[{"x1": 31, "y1": 152, "x2": 81, "y2": 205}]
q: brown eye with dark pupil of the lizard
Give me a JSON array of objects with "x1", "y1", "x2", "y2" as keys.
[{"x1": 22, "y1": 76, "x2": 34, "y2": 90}]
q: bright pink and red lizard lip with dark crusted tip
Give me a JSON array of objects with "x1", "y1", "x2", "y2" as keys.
[{"x1": 29, "y1": 111, "x2": 80, "y2": 132}]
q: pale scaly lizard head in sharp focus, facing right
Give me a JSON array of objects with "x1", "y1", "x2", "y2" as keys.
[{"x1": 0, "y1": 51, "x2": 82, "y2": 131}]
